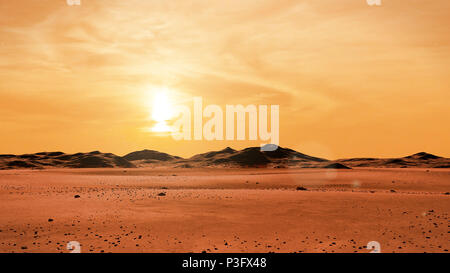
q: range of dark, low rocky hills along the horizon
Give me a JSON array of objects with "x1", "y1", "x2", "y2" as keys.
[{"x1": 0, "y1": 147, "x2": 450, "y2": 170}]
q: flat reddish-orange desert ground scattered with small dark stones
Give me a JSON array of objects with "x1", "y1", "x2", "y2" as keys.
[{"x1": 0, "y1": 168, "x2": 450, "y2": 253}]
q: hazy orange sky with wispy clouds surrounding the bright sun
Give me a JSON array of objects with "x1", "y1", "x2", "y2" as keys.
[{"x1": 0, "y1": 0, "x2": 450, "y2": 159}]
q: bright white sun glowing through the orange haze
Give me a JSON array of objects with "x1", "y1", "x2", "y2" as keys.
[{"x1": 151, "y1": 88, "x2": 173, "y2": 133}]
